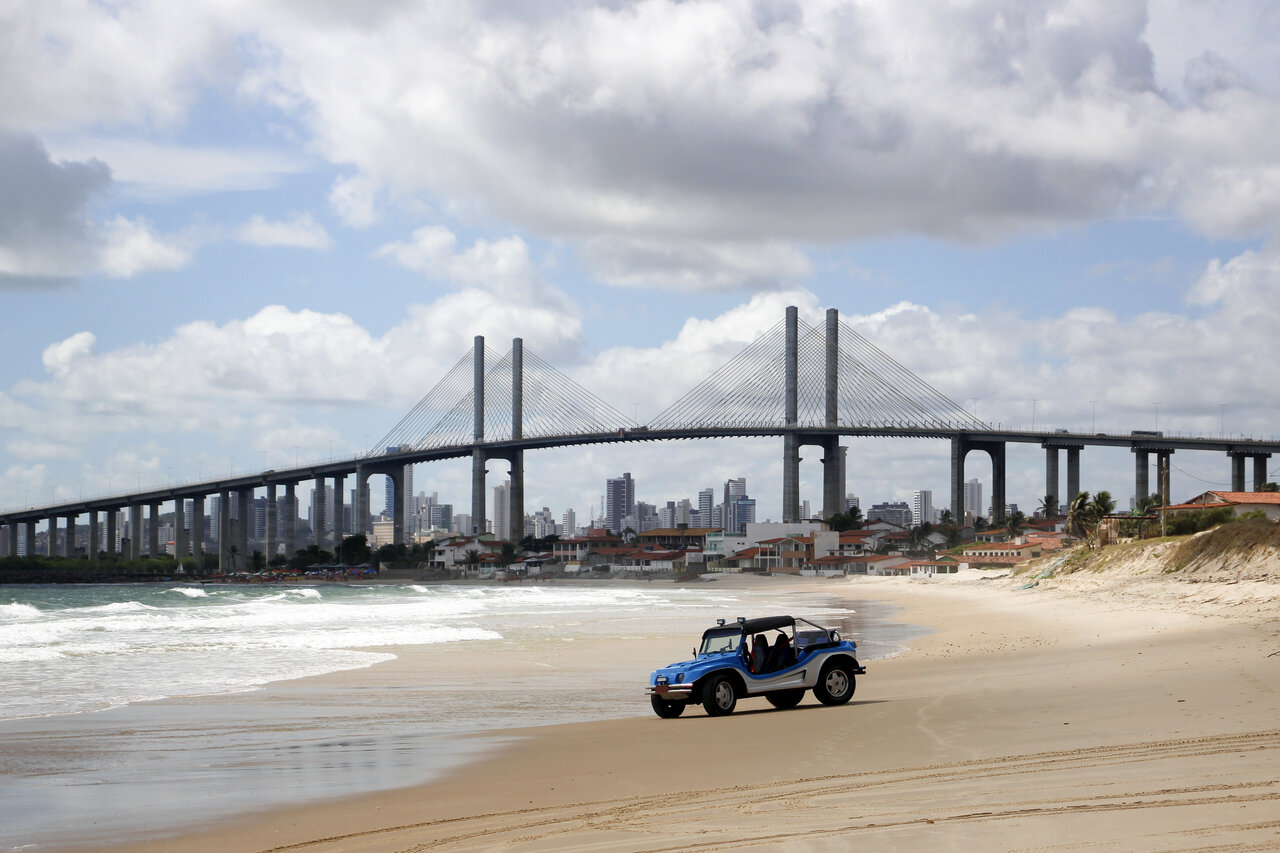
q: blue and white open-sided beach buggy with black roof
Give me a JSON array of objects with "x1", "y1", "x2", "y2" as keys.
[{"x1": 645, "y1": 616, "x2": 867, "y2": 719}]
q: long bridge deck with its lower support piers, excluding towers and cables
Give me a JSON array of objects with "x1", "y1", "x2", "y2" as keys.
[{"x1": 0, "y1": 424, "x2": 1280, "y2": 557}]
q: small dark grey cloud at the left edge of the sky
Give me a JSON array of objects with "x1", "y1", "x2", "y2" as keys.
[{"x1": 0, "y1": 132, "x2": 111, "y2": 283}]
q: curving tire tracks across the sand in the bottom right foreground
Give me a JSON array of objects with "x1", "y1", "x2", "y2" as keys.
[{"x1": 254, "y1": 730, "x2": 1280, "y2": 853}]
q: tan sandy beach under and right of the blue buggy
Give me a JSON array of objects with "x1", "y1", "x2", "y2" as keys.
[{"x1": 70, "y1": 558, "x2": 1280, "y2": 853}]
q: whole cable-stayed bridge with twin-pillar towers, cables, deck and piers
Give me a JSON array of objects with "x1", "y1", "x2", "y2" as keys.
[{"x1": 0, "y1": 307, "x2": 1280, "y2": 557}]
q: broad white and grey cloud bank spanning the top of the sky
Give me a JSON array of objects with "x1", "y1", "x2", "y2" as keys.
[{"x1": 10, "y1": 0, "x2": 1280, "y2": 291}]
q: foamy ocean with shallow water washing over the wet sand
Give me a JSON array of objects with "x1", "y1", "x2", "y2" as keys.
[{"x1": 0, "y1": 573, "x2": 919, "y2": 850}]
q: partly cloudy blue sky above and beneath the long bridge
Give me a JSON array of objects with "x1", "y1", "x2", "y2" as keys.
[{"x1": 0, "y1": 0, "x2": 1280, "y2": 520}]
